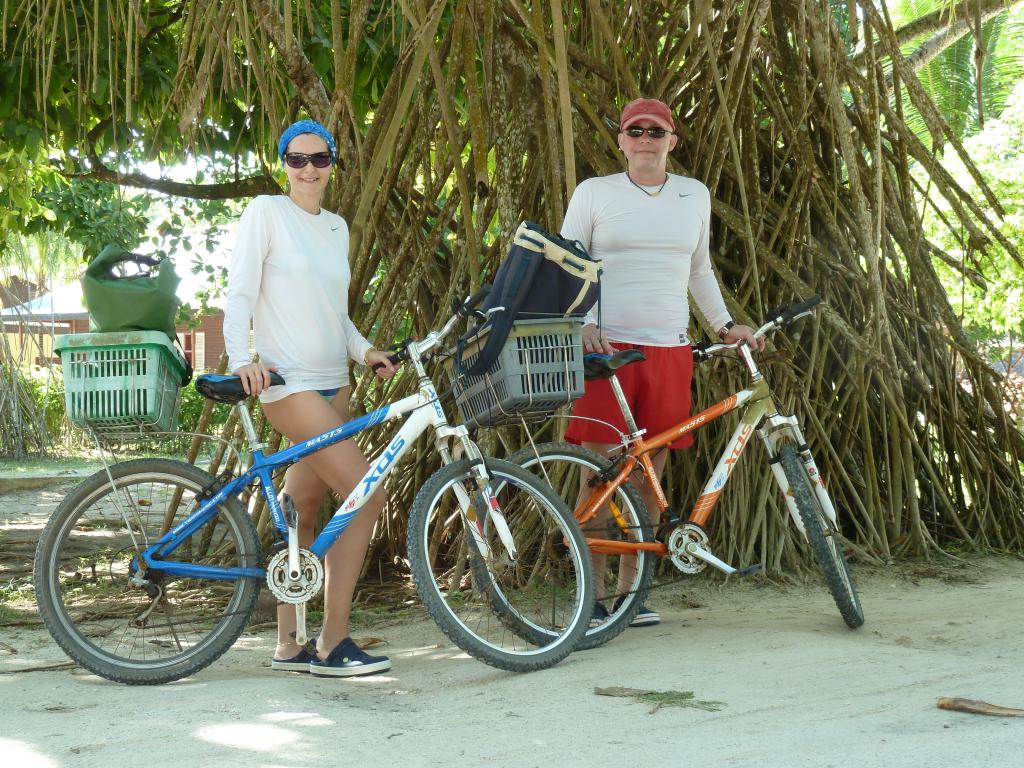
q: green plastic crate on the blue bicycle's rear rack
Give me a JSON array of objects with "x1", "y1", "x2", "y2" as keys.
[{"x1": 53, "y1": 331, "x2": 185, "y2": 436}]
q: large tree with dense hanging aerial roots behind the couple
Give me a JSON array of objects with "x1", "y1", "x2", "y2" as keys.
[{"x1": 0, "y1": 0, "x2": 1024, "y2": 569}]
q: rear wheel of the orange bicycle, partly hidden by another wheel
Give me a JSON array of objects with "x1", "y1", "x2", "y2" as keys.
[{"x1": 508, "y1": 442, "x2": 656, "y2": 650}]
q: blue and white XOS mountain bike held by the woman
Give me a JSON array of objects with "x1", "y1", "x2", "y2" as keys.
[{"x1": 34, "y1": 295, "x2": 593, "y2": 684}]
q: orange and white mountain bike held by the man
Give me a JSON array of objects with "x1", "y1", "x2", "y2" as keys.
[{"x1": 509, "y1": 296, "x2": 864, "y2": 648}]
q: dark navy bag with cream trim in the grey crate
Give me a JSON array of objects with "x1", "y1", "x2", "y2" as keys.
[{"x1": 455, "y1": 221, "x2": 601, "y2": 376}]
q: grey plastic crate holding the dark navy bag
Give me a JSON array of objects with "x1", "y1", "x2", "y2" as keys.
[{"x1": 450, "y1": 317, "x2": 584, "y2": 427}]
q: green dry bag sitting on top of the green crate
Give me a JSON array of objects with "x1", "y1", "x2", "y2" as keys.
[{"x1": 82, "y1": 246, "x2": 180, "y2": 340}]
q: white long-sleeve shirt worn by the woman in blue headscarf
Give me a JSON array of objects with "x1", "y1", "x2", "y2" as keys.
[{"x1": 224, "y1": 195, "x2": 372, "y2": 402}]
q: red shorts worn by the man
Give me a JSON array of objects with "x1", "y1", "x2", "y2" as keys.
[{"x1": 565, "y1": 341, "x2": 693, "y2": 449}]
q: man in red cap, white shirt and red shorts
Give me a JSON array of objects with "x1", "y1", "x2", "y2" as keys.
[{"x1": 561, "y1": 98, "x2": 764, "y2": 627}]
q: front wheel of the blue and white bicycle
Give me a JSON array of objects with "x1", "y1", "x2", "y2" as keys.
[{"x1": 409, "y1": 459, "x2": 593, "y2": 672}]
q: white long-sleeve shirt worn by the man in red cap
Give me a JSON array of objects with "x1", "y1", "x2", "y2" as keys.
[{"x1": 561, "y1": 173, "x2": 730, "y2": 346}]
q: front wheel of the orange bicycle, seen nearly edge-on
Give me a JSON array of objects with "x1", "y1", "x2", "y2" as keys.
[{"x1": 779, "y1": 443, "x2": 864, "y2": 630}]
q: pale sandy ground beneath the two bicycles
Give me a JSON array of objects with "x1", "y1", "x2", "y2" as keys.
[{"x1": 0, "y1": 489, "x2": 1024, "y2": 768}]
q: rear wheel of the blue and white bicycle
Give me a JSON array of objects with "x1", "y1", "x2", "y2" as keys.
[{"x1": 33, "y1": 459, "x2": 260, "y2": 685}]
